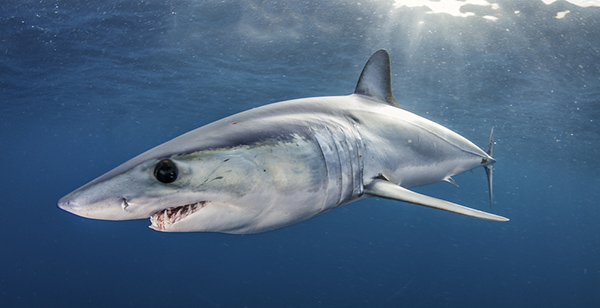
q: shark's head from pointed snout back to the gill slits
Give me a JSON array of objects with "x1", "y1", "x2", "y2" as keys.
[{"x1": 58, "y1": 114, "x2": 323, "y2": 234}]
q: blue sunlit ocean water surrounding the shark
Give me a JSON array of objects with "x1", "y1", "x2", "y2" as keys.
[{"x1": 0, "y1": 0, "x2": 600, "y2": 307}]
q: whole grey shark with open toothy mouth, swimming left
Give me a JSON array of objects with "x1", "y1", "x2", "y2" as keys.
[{"x1": 58, "y1": 50, "x2": 508, "y2": 234}]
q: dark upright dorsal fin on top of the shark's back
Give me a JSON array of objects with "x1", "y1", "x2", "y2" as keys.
[{"x1": 354, "y1": 49, "x2": 400, "y2": 107}]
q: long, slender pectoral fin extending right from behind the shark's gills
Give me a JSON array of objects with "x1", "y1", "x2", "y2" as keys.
[{"x1": 365, "y1": 179, "x2": 508, "y2": 221}]
